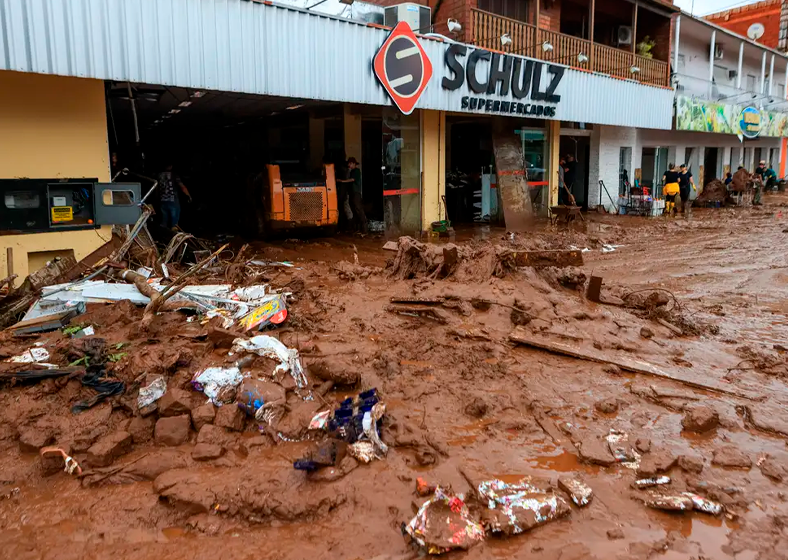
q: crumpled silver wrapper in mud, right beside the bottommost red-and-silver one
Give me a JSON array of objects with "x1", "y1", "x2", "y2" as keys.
[{"x1": 478, "y1": 477, "x2": 571, "y2": 535}]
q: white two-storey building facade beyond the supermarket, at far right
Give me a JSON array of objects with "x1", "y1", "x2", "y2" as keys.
[{"x1": 589, "y1": 14, "x2": 788, "y2": 206}]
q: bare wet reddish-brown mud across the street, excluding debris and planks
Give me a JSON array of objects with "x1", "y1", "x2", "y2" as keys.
[{"x1": 0, "y1": 197, "x2": 788, "y2": 560}]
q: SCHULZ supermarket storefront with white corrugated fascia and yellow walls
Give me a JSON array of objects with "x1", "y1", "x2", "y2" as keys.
[{"x1": 0, "y1": 0, "x2": 673, "y2": 271}]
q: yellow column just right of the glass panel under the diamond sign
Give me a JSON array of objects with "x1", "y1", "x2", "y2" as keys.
[{"x1": 421, "y1": 111, "x2": 446, "y2": 231}]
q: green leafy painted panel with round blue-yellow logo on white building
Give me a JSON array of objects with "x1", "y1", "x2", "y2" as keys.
[{"x1": 676, "y1": 96, "x2": 788, "y2": 138}]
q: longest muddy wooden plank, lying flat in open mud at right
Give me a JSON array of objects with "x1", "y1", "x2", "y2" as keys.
[{"x1": 509, "y1": 328, "x2": 765, "y2": 401}]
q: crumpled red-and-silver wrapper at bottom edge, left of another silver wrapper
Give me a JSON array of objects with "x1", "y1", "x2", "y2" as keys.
[{"x1": 406, "y1": 488, "x2": 484, "y2": 554}]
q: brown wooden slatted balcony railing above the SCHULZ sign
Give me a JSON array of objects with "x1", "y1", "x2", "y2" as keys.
[{"x1": 467, "y1": 8, "x2": 670, "y2": 86}]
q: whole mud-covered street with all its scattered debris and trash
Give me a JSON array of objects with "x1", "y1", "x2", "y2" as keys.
[{"x1": 0, "y1": 194, "x2": 788, "y2": 560}]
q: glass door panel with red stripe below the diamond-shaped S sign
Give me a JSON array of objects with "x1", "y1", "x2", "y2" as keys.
[{"x1": 381, "y1": 108, "x2": 421, "y2": 236}]
